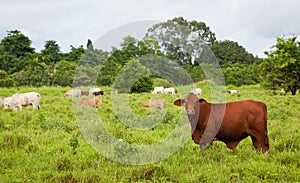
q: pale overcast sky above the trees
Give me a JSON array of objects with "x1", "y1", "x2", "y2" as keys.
[{"x1": 0, "y1": 0, "x2": 300, "y2": 57}]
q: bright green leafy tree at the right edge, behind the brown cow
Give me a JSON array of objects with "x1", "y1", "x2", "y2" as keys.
[{"x1": 262, "y1": 36, "x2": 300, "y2": 95}]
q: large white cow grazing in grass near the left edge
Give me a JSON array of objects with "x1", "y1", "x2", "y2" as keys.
[{"x1": 4, "y1": 92, "x2": 41, "y2": 110}]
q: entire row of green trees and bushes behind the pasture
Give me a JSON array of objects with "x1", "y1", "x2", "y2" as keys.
[{"x1": 0, "y1": 17, "x2": 300, "y2": 94}]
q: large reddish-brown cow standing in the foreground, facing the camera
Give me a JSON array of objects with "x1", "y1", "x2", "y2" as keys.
[{"x1": 174, "y1": 93, "x2": 269, "y2": 152}]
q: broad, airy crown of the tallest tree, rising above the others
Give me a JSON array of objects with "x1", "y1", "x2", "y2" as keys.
[{"x1": 146, "y1": 17, "x2": 216, "y2": 64}]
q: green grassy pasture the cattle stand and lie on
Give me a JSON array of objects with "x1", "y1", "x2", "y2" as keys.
[{"x1": 0, "y1": 86, "x2": 300, "y2": 182}]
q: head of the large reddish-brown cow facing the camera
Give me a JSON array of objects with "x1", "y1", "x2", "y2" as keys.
[{"x1": 174, "y1": 93, "x2": 206, "y2": 115}]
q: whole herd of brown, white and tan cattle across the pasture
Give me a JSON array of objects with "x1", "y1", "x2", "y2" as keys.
[{"x1": 0, "y1": 86, "x2": 269, "y2": 152}]
